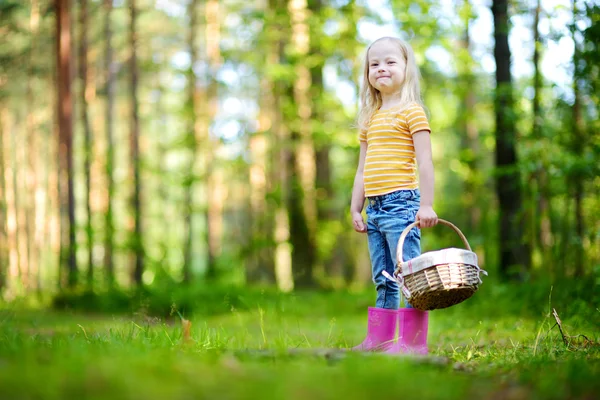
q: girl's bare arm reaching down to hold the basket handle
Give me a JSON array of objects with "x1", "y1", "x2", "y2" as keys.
[{"x1": 413, "y1": 131, "x2": 438, "y2": 228}]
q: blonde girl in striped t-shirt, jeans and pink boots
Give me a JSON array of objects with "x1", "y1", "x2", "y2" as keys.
[{"x1": 350, "y1": 37, "x2": 438, "y2": 353}]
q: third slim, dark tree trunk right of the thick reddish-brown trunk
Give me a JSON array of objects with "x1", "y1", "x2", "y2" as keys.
[{"x1": 129, "y1": 0, "x2": 144, "y2": 286}]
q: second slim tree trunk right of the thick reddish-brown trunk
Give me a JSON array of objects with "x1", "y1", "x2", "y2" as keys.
[{"x1": 104, "y1": 0, "x2": 115, "y2": 287}]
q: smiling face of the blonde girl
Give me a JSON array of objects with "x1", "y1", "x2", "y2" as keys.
[{"x1": 367, "y1": 40, "x2": 406, "y2": 94}]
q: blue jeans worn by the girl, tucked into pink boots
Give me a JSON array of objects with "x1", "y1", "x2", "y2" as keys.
[{"x1": 367, "y1": 189, "x2": 421, "y2": 309}]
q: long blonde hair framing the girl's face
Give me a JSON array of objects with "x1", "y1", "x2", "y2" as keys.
[{"x1": 358, "y1": 36, "x2": 423, "y2": 132}]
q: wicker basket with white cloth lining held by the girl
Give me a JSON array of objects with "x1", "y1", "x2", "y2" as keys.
[{"x1": 386, "y1": 219, "x2": 487, "y2": 310}]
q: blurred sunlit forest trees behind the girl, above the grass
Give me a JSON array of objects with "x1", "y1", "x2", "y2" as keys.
[{"x1": 0, "y1": 0, "x2": 600, "y2": 299}]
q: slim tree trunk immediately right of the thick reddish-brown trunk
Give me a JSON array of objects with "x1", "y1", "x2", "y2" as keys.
[{"x1": 79, "y1": 0, "x2": 94, "y2": 289}]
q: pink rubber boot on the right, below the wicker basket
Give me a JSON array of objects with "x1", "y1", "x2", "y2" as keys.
[{"x1": 386, "y1": 308, "x2": 429, "y2": 354}]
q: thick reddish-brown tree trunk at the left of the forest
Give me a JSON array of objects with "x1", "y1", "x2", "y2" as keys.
[{"x1": 55, "y1": 0, "x2": 78, "y2": 288}]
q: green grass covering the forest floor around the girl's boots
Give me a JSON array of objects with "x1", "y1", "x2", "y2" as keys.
[{"x1": 0, "y1": 285, "x2": 600, "y2": 400}]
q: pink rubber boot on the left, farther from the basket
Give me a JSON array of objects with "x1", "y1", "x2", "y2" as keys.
[{"x1": 351, "y1": 307, "x2": 398, "y2": 351}]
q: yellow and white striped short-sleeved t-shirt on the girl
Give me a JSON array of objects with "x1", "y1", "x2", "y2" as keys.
[{"x1": 359, "y1": 103, "x2": 431, "y2": 197}]
